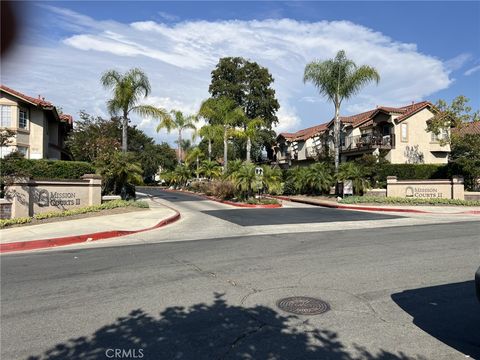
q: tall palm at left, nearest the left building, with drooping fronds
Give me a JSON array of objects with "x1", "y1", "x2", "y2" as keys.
[{"x1": 100, "y1": 68, "x2": 166, "y2": 152}]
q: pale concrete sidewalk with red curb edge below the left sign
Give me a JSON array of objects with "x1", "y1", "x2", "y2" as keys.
[{"x1": 0, "y1": 201, "x2": 180, "y2": 252}]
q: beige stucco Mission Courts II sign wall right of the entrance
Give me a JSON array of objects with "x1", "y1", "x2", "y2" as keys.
[{"x1": 387, "y1": 176, "x2": 464, "y2": 200}]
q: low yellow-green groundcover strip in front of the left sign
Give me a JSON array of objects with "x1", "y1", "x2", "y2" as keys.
[{"x1": 0, "y1": 200, "x2": 149, "y2": 229}]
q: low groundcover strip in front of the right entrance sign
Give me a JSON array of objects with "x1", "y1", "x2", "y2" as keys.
[{"x1": 339, "y1": 196, "x2": 480, "y2": 206}]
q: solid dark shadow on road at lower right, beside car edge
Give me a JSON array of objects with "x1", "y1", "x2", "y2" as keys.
[{"x1": 392, "y1": 281, "x2": 480, "y2": 359}]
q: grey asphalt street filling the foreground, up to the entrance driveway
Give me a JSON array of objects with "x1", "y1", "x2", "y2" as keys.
[{"x1": 1, "y1": 190, "x2": 480, "y2": 360}]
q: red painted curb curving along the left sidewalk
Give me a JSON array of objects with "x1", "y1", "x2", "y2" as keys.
[{"x1": 0, "y1": 209, "x2": 180, "y2": 253}]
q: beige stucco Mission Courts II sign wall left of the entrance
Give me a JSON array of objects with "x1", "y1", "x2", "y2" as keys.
[{"x1": 5, "y1": 174, "x2": 102, "y2": 218}]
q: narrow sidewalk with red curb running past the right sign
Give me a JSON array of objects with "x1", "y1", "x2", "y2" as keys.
[{"x1": 275, "y1": 195, "x2": 480, "y2": 215}]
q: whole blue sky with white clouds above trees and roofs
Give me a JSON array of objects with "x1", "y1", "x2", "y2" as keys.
[{"x1": 1, "y1": 1, "x2": 480, "y2": 143}]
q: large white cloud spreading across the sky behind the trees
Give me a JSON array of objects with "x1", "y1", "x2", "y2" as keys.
[{"x1": 2, "y1": 5, "x2": 456, "y2": 143}]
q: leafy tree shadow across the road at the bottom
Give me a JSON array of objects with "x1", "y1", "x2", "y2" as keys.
[{"x1": 29, "y1": 294, "x2": 422, "y2": 360}]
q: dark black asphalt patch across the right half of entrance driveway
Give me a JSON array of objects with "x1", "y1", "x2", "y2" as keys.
[{"x1": 203, "y1": 208, "x2": 402, "y2": 226}]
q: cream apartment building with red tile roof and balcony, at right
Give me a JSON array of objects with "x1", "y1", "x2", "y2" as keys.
[{"x1": 274, "y1": 101, "x2": 450, "y2": 167}]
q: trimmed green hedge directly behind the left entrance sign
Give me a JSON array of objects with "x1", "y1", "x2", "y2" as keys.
[{"x1": 1, "y1": 159, "x2": 95, "y2": 179}]
